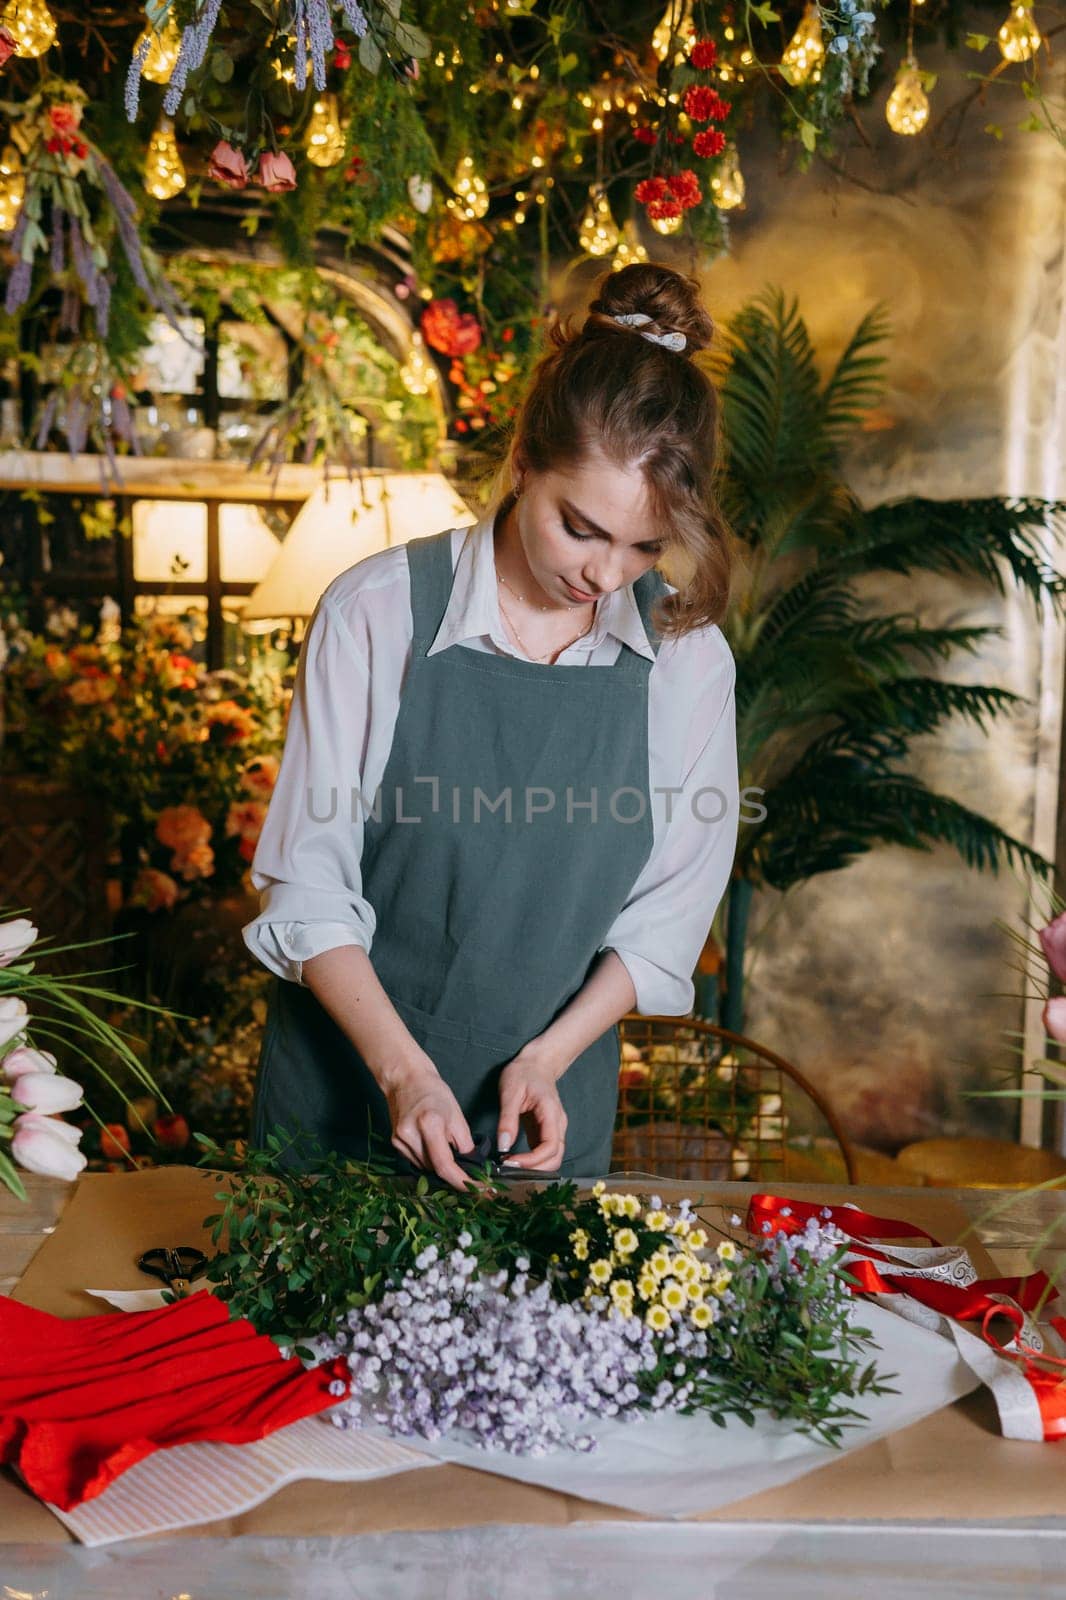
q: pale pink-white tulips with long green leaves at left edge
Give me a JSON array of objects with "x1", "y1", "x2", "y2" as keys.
[{"x1": 0, "y1": 915, "x2": 164, "y2": 1200}]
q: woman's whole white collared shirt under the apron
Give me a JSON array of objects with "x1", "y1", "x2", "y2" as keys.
[{"x1": 243, "y1": 517, "x2": 738, "y2": 1016}]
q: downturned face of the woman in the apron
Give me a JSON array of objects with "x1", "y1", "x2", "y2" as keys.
[{"x1": 514, "y1": 450, "x2": 667, "y2": 605}]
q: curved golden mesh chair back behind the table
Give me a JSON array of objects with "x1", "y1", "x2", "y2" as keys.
[{"x1": 611, "y1": 1013, "x2": 855, "y2": 1182}]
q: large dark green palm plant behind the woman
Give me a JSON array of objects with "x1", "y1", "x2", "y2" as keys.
[{"x1": 704, "y1": 288, "x2": 1066, "y2": 1032}]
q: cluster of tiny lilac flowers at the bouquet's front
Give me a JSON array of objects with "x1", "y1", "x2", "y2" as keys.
[{"x1": 315, "y1": 1245, "x2": 681, "y2": 1456}]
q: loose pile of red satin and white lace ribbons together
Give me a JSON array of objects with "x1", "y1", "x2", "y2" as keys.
[{"x1": 747, "y1": 1194, "x2": 1066, "y2": 1440}]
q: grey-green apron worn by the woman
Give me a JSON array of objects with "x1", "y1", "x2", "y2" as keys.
[{"x1": 253, "y1": 533, "x2": 664, "y2": 1178}]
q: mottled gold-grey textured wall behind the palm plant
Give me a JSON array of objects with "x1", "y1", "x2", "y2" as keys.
[{"x1": 669, "y1": 22, "x2": 1066, "y2": 1149}]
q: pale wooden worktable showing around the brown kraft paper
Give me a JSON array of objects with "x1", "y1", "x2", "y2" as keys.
[{"x1": 0, "y1": 1178, "x2": 1066, "y2": 1600}]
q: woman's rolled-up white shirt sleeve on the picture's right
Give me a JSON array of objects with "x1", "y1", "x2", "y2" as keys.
[{"x1": 600, "y1": 640, "x2": 739, "y2": 1016}]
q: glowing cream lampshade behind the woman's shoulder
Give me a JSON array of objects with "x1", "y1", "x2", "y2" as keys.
[{"x1": 240, "y1": 470, "x2": 477, "y2": 624}]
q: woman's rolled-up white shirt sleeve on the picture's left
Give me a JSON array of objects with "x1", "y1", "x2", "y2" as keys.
[{"x1": 242, "y1": 590, "x2": 376, "y2": 982}]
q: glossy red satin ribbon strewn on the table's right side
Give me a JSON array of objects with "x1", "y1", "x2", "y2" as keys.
[{"x1": 746, "y1": 1194, "x2": 1066, "y2": 1440}]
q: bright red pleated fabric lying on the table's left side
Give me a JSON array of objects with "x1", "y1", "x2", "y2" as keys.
[{"x1": 0, "y1": 1293, "x2": 347, "y2": 1510}]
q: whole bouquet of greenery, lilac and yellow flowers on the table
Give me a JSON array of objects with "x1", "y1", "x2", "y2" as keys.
[{"x1": 196, "y1": 1138, "x2": 880, "y2": 1454}]
